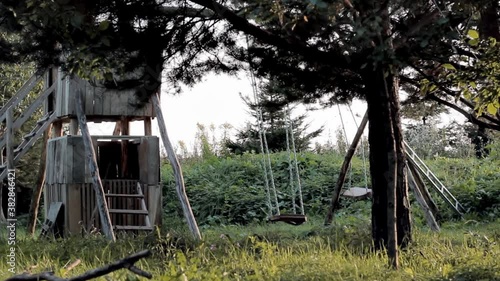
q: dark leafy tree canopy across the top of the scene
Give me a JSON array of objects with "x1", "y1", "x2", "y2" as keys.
[{"x1": 0, "y1": 0, "x2": 500, "y2": 129}]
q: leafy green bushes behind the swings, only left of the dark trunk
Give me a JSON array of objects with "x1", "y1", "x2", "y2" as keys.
[{"x1": 163, "y1": 153, "x2": 365, "y2": 225}]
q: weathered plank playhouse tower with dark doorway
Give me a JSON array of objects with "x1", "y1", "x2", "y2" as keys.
[{"x1": 44, "y1": 70, "x2": 162, "y2": 234}]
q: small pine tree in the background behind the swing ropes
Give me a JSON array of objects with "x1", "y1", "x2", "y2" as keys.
[{"x1": 226, "y1": 80, "x2": 323, "y2": 154}]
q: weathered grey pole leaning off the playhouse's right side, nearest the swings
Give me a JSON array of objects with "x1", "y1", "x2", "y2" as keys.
[{"x1": 151, "y1": 93, "x2": 201, "y2": 240}]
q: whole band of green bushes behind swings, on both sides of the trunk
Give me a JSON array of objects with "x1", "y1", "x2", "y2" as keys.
[{"x1": 163, "y1": 149, "x2": 500, "y2": 225}]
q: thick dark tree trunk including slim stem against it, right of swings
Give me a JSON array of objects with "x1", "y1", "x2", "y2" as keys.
[{"x1": 364, "y1": 69, "x2": 411, "y2": 267}]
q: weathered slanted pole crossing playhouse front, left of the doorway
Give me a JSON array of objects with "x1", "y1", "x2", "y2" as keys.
[{"x1": 76, "y1": 90, "x2": 116, "y2": 242}]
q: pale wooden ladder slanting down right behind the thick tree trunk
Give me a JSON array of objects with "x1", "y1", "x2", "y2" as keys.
[{"x1": 404, "y1": 142, "x2": 466, "y2": 216}]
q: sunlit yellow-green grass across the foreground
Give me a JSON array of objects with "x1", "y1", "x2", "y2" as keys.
[{"x1": 0, "y1": 218, "x2": 500, "y2": 280}]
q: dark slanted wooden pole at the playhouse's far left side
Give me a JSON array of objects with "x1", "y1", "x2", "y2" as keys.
[{"x1": 28, "y1": 125, "x2": 51, "y2": 235}]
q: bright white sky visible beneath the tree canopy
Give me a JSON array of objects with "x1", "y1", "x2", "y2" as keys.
[{"x1": 89, "y1": 70, "x2": 464, "y2": 153}]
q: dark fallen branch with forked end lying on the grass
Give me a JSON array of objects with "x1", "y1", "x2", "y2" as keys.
[{"x1": 5, "y1": 250, "x2": 153, "y2": 281}]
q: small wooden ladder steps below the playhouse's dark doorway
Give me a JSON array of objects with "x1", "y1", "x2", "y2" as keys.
[{"x1": 106, "y1": 182, "x2": 154, "y2": 231}]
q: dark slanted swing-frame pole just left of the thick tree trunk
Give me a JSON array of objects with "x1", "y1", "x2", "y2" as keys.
[{"x1": 325, "y1": 111, "x2": 368, "y2": 225}]
